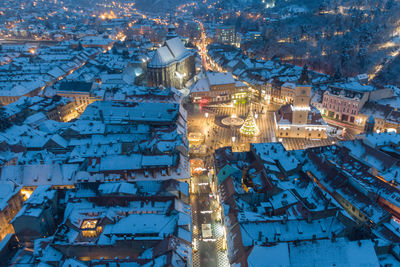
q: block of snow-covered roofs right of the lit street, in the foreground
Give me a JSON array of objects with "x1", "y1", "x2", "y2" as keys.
[{"x1": 213, "y1": 137, "x2": 400, "y2": 266}]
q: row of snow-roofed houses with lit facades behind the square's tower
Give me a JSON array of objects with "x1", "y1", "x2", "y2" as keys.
[{"x1": 208, "y1": 44, "x2": 399, "y2": 132}]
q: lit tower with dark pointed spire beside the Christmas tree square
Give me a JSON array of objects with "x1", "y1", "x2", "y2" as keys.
[{"x1": 292, "y1": 65, "x2": 311, "y2": 125}]
